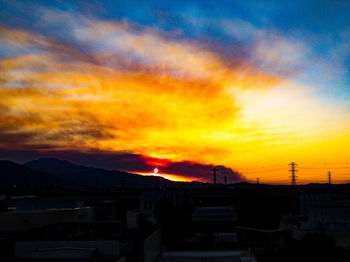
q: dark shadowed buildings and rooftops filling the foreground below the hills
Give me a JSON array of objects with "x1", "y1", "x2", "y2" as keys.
[{"x1": 0, "y1": 184, "x2": 350, "y2": 262}]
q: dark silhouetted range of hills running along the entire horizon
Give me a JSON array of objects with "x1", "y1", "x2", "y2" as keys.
[{"x1": 0, "y1": 158, "x2": 350, "y2": 190}]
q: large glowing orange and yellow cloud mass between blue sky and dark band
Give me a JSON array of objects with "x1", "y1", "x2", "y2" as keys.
[{"x1": 0, "y1": 13, "x2": 350, "y2": 182}]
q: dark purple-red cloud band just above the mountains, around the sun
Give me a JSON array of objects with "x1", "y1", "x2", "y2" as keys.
[{"x1": 0, "y1": 148, "x2": 245, "y2": 183}]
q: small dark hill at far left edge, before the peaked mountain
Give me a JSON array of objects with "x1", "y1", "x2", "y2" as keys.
[{"x1": 0, "y1": 160, "x2": 63, "y2": 187}]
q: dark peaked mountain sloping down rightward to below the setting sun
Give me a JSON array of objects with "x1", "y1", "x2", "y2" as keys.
[{"x1": 24, "y1": 158, "x2": 174, "y2": 188}]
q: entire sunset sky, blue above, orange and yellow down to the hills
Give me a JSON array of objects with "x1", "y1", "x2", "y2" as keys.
[{"x1": 0, "y1": 0, "x2": 350, "y2": 184}]
